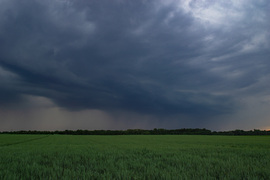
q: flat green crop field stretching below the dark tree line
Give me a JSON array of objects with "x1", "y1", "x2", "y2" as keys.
[{"x1": 0, "y1": 134, "x2": 270, "y2": 180}]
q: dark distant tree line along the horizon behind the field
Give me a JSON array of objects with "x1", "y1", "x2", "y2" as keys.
[{"x1": 0, "y1": 128, "x2": 270, "y2": 136}]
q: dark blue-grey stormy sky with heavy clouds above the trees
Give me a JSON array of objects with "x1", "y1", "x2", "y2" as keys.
[{"x1": 0, "y1": 0, "x2": 270, "y2": 131}]
